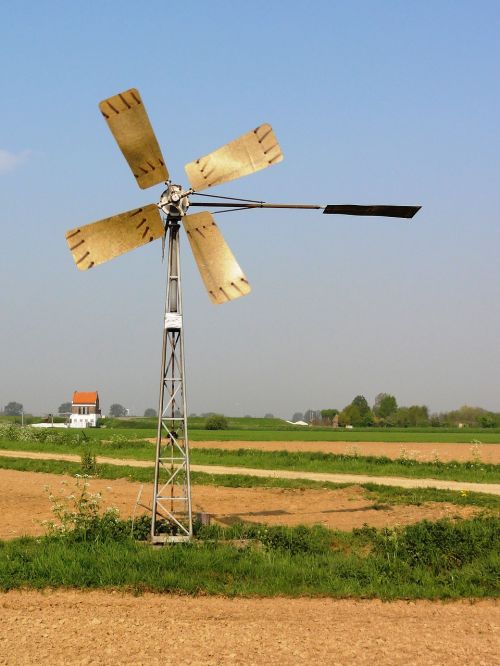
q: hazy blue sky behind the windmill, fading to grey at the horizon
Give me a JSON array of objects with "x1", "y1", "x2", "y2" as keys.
[{"x1": 0, "y1": 0, "x2": 500, "y2": 418}]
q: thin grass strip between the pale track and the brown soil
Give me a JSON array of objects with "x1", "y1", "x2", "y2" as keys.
[{"x1": 0, "y1": 453, "x2": 500, "y2": 511}]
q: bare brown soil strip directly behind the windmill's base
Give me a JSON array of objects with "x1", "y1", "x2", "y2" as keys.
[{"x1": 0, "y1": 470, "x2": 475, "y2": 539}]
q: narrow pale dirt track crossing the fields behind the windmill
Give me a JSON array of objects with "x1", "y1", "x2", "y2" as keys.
[{"x1": 0, "y1": 450, "x2": 500, "y2": 495}]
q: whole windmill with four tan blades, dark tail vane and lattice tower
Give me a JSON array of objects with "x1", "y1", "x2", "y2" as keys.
[{"x1": 66, "y1": 88, "x2": 420, "y2": 543}]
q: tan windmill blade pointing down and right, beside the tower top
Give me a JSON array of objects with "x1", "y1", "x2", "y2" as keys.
[{"x1": 182, "y1": 212, "x2": 251, "y2": 303}]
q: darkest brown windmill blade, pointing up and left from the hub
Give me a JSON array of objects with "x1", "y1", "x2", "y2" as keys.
[{"x1": 99, "y1": 88, "x2": 168, "y2": 189}]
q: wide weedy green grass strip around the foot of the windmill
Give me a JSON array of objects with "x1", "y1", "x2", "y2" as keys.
[{"x1": 0, "y1": 517, "x2": 500, "y2": 599}]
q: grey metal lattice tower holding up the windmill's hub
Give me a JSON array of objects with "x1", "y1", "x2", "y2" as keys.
[{"x1": 151, "y1": 219, "x2": 193, "y2": 544}]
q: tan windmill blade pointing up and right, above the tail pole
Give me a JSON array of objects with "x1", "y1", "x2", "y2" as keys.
[{"x1": 185, "y1": 124, "x2": 283, "y2": 191}]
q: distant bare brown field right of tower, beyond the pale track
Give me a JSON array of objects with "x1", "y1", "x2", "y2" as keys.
[{"x1": 187, "y1": 440, "x2": 500, "y2": 465}]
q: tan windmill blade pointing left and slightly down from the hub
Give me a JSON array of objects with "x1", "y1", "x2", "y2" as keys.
[{"x1": 66, "y1": 204, "x2": 165, "y2": 271}]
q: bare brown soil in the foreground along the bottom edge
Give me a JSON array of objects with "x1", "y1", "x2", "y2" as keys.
[{"x1": 0, "y1": 591, "x2": 499, "y2": 666}]
